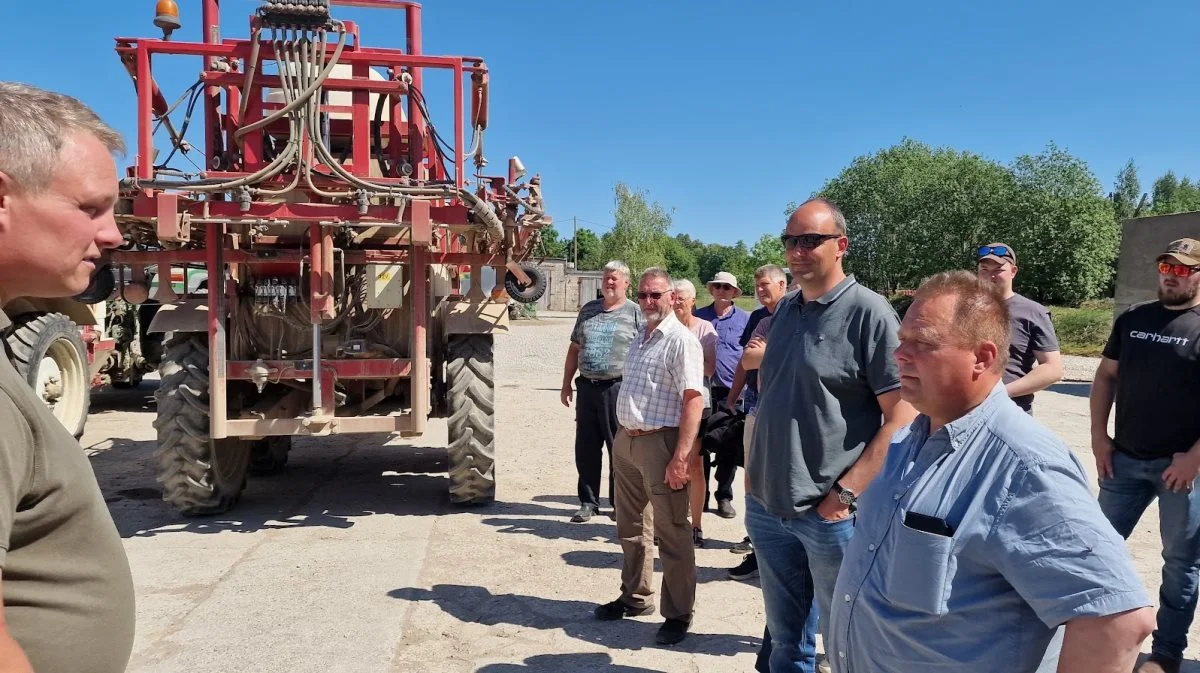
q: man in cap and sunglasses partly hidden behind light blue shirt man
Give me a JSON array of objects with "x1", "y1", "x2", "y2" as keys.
[{"x1": 976, "y1": 238, "x2": 1062, "y2": 414}]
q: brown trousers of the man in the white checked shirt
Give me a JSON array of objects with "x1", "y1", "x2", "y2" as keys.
[{"x1": 612, "y1": 428, "x2": 696, "y2": 621}]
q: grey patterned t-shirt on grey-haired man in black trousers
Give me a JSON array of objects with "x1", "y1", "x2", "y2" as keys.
[{"x1": 571, "y1": 299, "x2": 643, "y2": 379}]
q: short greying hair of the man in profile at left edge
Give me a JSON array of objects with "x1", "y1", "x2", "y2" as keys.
[{"x1": 0, "y1": 82, "x2": 125, "y2": 193}]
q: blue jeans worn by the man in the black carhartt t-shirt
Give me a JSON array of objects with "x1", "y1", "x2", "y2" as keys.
[{"x1": 1099, "y1": 451, "x2": 1200, "y2": 661}]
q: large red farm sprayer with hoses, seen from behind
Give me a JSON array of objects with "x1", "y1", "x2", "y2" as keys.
[{"x1": 110, "y1": 0, "x2": 552, "y2": 516}]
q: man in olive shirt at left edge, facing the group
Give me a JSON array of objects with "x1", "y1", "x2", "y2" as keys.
[{"x1": 0, "y1": 82, "x2": 133, "y2": 673}]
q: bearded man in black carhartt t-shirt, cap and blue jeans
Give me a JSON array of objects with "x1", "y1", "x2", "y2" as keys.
[{"x1": 1091, "y1": 239, "x2": 1200, "y2": 673}]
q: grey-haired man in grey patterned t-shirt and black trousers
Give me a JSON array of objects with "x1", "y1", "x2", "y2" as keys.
[{"x1": 562, "y1": 260, "x2": 643, "y2": 523}]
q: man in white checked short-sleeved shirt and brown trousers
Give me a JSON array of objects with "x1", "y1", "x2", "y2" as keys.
[{"x1": 595, "y1": 263, "x2": 704, "y2": 645}]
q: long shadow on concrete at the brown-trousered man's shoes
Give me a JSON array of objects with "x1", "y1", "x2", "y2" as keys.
[{"x1": 388, "y1": 584, "x2": 760, "y2": 657}]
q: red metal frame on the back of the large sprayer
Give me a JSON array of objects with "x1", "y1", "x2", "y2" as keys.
[{"x1": 113, "y1": 0, "x2": 534, "y2": 438}]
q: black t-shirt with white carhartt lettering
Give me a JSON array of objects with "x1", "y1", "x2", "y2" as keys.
[{"x1": 1104, "y1": 301, "x2": 1200, "y2": 458}]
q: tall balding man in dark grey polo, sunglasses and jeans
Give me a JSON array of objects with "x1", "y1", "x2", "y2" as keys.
[{"x1": 746, "y1": 199, "x2": 916, "y2": 673}]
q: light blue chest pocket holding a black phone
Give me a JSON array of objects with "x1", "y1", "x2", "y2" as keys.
[{"x1": 883, "y1": 522, "x2": 956, "y2": 615}]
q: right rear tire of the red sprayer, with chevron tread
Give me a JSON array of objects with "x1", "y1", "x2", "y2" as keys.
[{"x1": 446, "y1": 335, "x2": 496, "y2": 505}]
